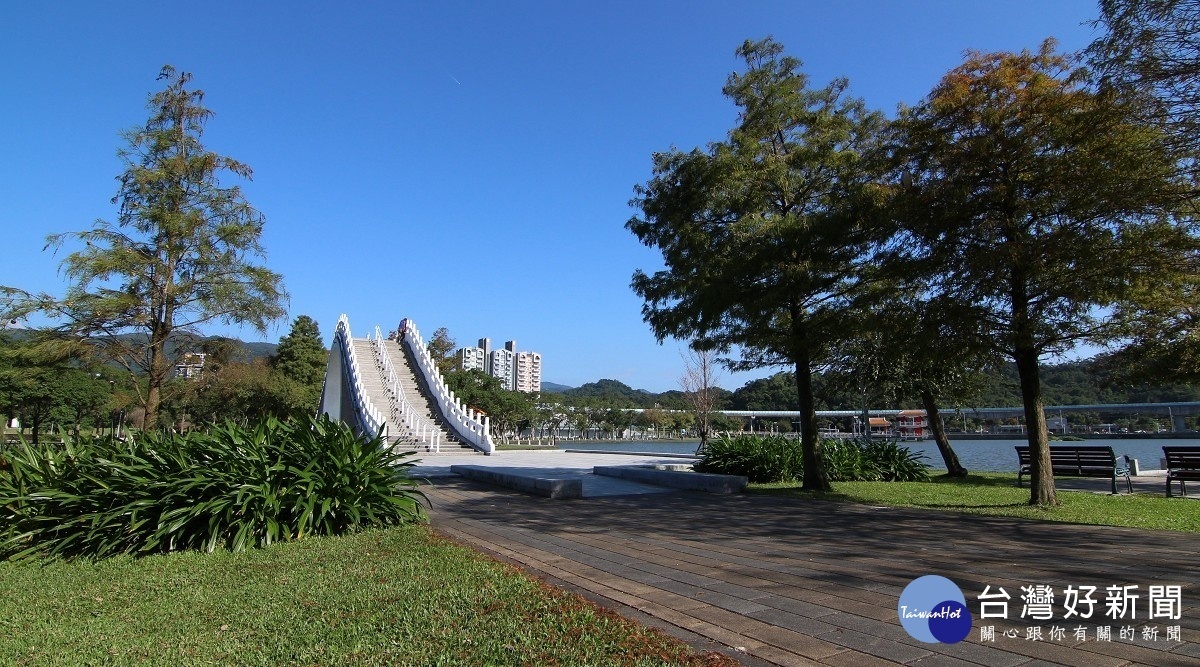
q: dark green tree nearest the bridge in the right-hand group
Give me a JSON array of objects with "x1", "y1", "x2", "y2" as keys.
[{"x1": 626, "y1": 38, "x2": 882, "y2": 491}]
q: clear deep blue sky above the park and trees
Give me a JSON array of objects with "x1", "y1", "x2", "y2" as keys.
[{"x1": 0, "y1": 0, "x2": 1097, "y2": 391}]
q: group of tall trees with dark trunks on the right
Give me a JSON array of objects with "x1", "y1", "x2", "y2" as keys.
[{"x1": 626, "y1": 0, "x2": 1200, "y2": 505}]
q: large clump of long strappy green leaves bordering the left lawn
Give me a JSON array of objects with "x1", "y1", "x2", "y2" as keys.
[{"x1": 0, "y1": 415, "x2": 424, "y2": 559}]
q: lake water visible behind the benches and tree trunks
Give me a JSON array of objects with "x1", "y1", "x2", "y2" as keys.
[{"x1": 558, "y1": 438, "x2": 1200, "y2": 474}]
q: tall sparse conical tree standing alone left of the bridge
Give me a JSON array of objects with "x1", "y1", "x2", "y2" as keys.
[{"x1": 0, "y1": 66, "x2": 286, "y2": 427}]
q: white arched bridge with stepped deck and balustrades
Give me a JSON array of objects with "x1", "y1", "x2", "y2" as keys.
[{"x1": 319, "y1": 316, "x2": 496, "y2": 455}]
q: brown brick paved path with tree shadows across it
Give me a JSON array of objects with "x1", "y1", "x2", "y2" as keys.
[{"x1": 426, "y1": 477, "x2": 1200, "y2": 667}]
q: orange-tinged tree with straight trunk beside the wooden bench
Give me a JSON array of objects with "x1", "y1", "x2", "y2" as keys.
[{"x1": 892, "y1": 40, "x2": 1195, "y2": 505}]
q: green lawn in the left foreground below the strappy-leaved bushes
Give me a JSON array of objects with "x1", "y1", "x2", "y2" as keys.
[{"x1": 0, "y1": 525, "x2": 730, "y2": 666}]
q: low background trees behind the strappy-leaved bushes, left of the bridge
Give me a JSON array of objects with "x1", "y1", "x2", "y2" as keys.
[{"x1": 0, "y1": 316, "x2": 329, "y2": 443}]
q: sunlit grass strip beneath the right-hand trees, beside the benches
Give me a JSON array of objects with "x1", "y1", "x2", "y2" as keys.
[{"x1": 750, "y1": 473, "x2": 1200, "y2": 533}]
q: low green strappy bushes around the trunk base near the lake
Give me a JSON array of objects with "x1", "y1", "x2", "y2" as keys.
[{"x1": 695, "y1": 435, "x2": 929, "y2": 483}]
